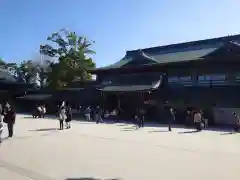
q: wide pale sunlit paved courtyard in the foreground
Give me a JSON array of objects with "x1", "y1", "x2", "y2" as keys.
[{"x1": 0, "y1": 115, "x2": 240, "y2": 180}]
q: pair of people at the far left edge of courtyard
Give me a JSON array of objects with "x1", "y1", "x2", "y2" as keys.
[{"x1": 0, "y1": 102, "x2": 16, "y2": 142}]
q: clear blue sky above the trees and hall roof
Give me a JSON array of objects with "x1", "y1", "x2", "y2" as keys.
[{"x1": 0, "y1": 0, "x2": 240, "y2": 67}]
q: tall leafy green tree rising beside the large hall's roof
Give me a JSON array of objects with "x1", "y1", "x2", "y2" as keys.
[{"x1": 40, "y1": 29, "x2": 95, "y2": 88}]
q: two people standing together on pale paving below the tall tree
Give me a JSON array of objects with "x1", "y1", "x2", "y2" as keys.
[{"x1": 58, "y1": 102, "x2": 72, "y2": 130}]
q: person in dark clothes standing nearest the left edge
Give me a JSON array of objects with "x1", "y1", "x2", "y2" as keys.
[{"x1": 4, "y1": 106, "x2": 16, "y2": 137}]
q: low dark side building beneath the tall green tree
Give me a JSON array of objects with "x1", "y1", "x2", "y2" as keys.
[{"x1": 17, "y1": 81, "x2": 101, "y2": 113}]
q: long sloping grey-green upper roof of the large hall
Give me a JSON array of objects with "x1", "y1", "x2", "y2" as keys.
[{"x1": 92, "y1": 35, "x2": 240, "y2": 70}]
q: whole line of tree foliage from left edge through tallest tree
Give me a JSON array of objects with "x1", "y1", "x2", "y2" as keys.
[{"x1": 0, "y1": 29, "x2": 95, "y2": 89}]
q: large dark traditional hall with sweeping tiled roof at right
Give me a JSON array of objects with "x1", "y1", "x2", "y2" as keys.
[{"x1": 90, "y1": 35, "x2": 240, "y2": 124}]
